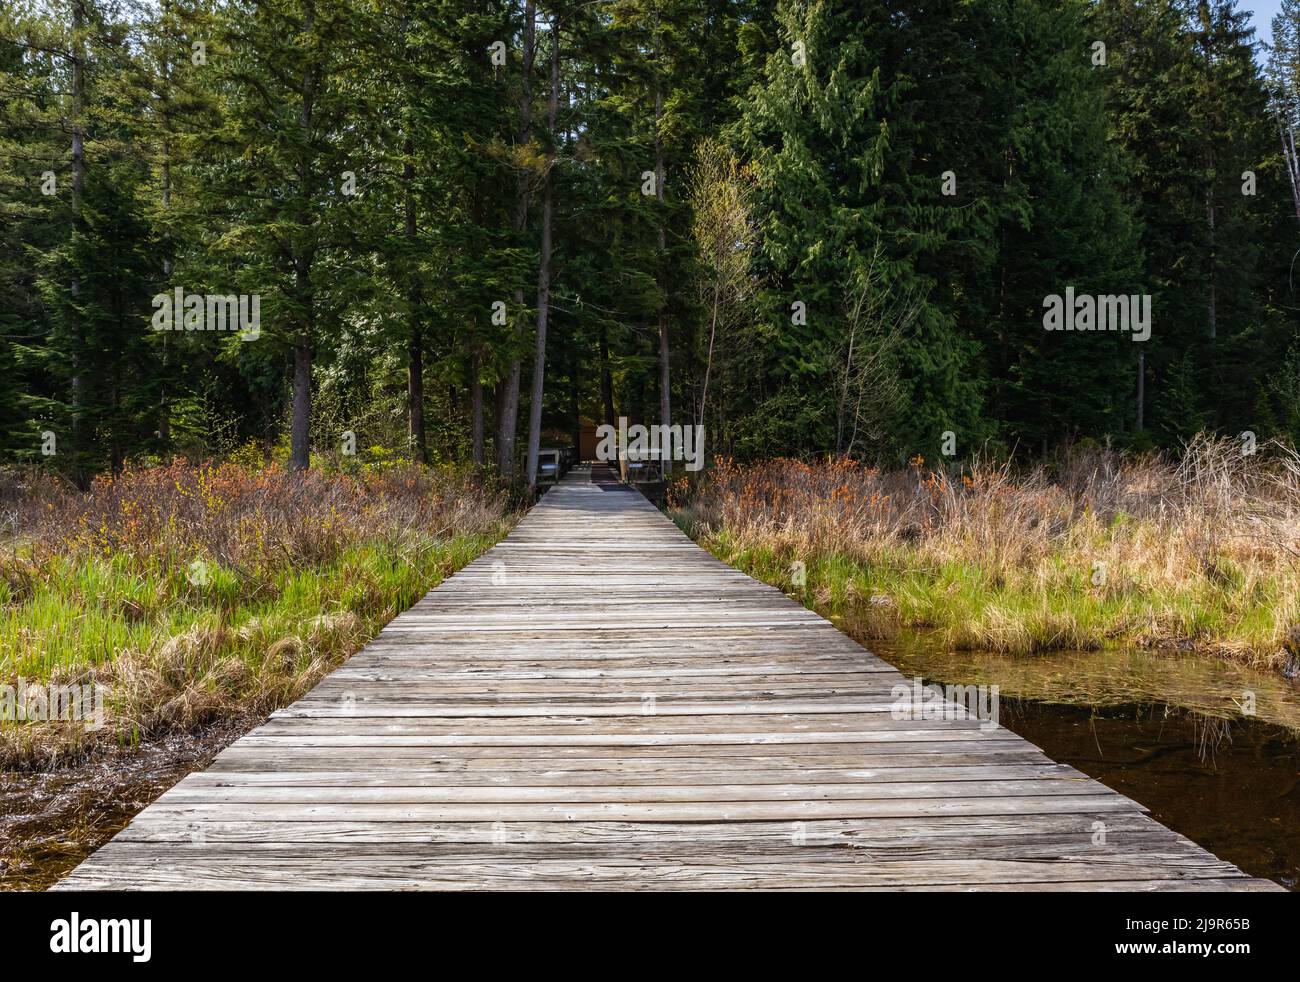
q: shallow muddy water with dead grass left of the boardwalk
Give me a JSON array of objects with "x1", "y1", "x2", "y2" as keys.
[{"x1": 0, "y1": 721, "x2": 245, "y2": 890}]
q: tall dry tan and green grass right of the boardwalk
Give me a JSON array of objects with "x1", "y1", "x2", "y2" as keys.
[{"x1": 672, "y1": 436, "x2": 1300, "y2": 671}]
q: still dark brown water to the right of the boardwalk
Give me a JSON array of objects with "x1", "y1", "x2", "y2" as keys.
[{"x1": 863, "y1": 637, "x2": 1300, "y2": 890}]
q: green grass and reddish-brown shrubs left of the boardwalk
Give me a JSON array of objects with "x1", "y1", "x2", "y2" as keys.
[{"x1": 0, "y1": 463, "x2": 511, "y2": 766}]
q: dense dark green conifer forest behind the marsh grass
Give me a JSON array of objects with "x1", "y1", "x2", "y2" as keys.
[{"x1": 0, "y1": 0, "x2": 1300, "y2": 486}]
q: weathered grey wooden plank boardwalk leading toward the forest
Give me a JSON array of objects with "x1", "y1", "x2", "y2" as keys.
[{"x1": 56, "y1": 471, "x2": 1278, "y2": 891}]
